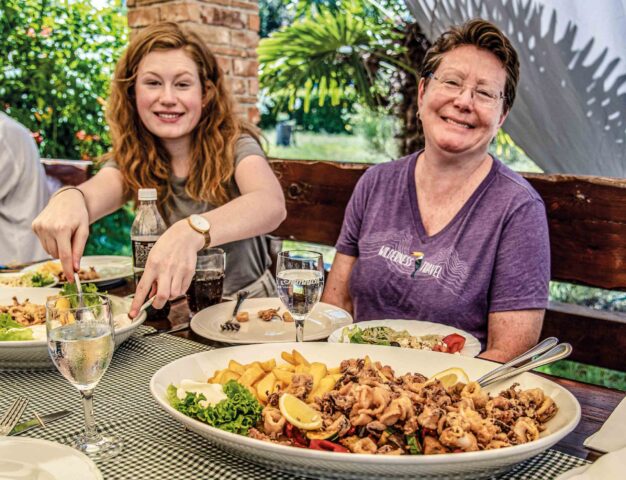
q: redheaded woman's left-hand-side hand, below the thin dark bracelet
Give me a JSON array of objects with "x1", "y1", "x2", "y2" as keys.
[{"x1": 32, "y1": 188, "x2": 89, "y2": 282}]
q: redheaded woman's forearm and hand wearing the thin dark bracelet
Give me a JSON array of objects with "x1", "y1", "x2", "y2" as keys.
[{"x1": 33, "y1": 168, "x2": 124, "y2": 279}]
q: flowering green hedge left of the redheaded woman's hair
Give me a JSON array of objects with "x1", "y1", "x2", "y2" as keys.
[{"x1": 0, "y1": 0, "x2": 126, "y2": 159}]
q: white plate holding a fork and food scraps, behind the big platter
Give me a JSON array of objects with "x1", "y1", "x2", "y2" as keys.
[{"x1": 191, "y1": 297, "x2": 352, "y2": 344}]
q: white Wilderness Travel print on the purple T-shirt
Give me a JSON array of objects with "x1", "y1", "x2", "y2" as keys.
[{"x1": 359, "y1": 229, "x2": 469, "y2": 297}]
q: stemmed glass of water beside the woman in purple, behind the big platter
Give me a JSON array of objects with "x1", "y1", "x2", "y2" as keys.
[{"x1": 276, "y1": 250, "x2": 324, "y2": 342}]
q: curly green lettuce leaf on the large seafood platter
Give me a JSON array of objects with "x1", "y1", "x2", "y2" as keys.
[{"x1": 167, "y1": 380, "x2": 263, "y2": 435}]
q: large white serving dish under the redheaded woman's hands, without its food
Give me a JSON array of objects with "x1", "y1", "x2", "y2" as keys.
[{"x1": 0, "y1": 287, "x2": 146, "y2": 369}]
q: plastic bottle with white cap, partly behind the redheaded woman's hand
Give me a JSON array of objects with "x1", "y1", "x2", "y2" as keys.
[{"x1": 130, "y1": 188, "x2": 170, "y2": 320}]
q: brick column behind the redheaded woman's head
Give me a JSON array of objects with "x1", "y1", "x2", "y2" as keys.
[{"x1": 126, "y1": 0, "x2": 260, "y2": 123}]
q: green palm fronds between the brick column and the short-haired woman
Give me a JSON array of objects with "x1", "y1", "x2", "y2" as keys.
[{"x1": 257, "y1": 0, "x2": 410, "y2": 112}]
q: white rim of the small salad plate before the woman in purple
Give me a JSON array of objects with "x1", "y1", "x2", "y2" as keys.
[{"x1": 328, "y1": 320, "x2": 481, "y2": 357}]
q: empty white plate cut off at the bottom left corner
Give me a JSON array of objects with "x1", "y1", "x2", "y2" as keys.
[{"x1": 0, "y1": 438, "x2": 103, "y2": 480}]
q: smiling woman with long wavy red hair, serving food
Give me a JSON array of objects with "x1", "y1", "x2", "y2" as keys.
[{"x1": 33, "y1": 22, "x2": 286, "y2": 316}]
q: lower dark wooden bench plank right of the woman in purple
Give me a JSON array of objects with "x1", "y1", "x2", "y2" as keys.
[{"x1": 541, "y1": 302, "x2": 626, "y2": 371}]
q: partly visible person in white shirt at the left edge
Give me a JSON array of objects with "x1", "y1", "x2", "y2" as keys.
[{"x1": 0, "y1": 112, "x2": 50, "y2": 265}]
